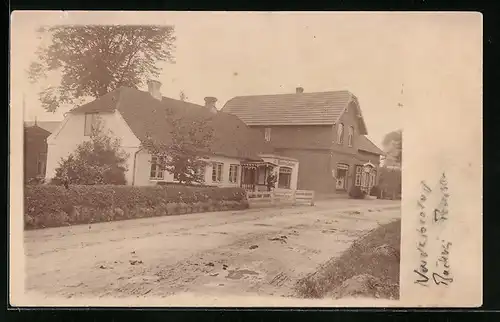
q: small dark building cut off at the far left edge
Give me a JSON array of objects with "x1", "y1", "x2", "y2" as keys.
[{"x1": 24, "y1": 123, "x2": 50, "y2": 182}]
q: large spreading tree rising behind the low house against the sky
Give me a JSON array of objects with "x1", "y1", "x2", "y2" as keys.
[{"x1": 28, "y1": 25, "x2": 175, "y2": 112}]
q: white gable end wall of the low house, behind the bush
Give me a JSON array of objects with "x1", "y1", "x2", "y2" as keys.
[{"x1": 46, "y1": 111, "x2": 140, "y2": 183}]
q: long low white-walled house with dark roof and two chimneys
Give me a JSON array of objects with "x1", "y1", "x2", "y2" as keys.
[{"x1": 47, "y1": 81, "x2": 299, "y2": 190}]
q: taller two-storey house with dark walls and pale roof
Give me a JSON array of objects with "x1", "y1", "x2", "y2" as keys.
[{"x1": 222, "y1": 87, "x2": 383, "y2": 193}]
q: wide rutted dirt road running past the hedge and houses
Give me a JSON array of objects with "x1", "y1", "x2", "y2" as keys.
[{"x1": 24, "y1": 200, "x2": 401, "y2": 298}]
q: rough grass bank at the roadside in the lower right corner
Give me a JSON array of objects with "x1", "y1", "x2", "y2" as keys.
[{"x1": 295, "y1": 220, "x2": 401, "y2": 299}]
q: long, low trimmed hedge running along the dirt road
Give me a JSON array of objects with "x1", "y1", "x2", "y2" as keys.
[{"x1": 24, "y1": 185, "x2": 248, "y2": 229}]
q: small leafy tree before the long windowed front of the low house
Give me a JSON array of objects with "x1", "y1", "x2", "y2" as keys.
[{"x1": 145, "y1": 113, "x2": 214, "y2": 185}]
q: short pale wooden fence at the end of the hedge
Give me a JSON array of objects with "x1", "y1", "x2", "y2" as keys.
[{"x1": 247, "y1": 189, "x2": 314, "y2": 206}]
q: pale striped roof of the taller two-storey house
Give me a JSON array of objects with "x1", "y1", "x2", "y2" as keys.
[{"x1": 222, "y1": 91, "x2": 366, "y2": 132}]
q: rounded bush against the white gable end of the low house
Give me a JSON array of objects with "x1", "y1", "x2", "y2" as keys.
[{"x1": 52, "y1": 121, "x2": 128, "y2": 186}]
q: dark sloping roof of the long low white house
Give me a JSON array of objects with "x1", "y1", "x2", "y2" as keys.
[{"x1": 70, "y1": 87, "x2": 273, "y2": 160}]
